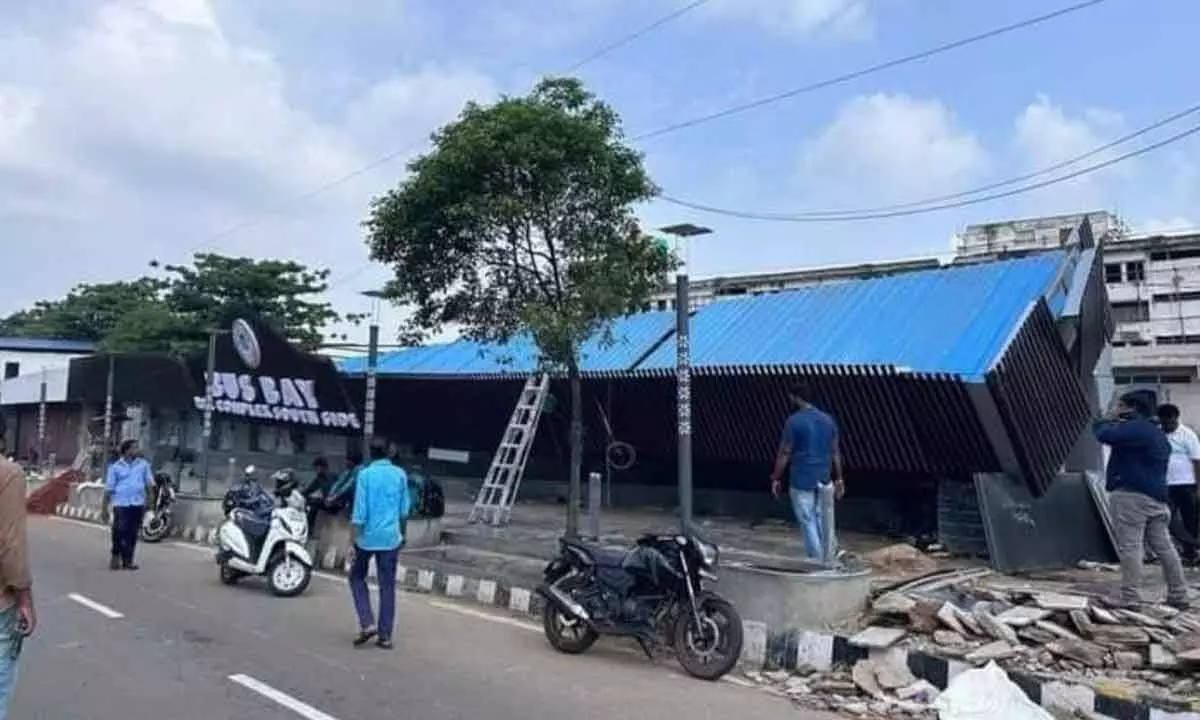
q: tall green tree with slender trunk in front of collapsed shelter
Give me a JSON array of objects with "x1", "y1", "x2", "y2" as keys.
[{"x1": 365, "y1": 78, "x2": 674, "y2": 534}]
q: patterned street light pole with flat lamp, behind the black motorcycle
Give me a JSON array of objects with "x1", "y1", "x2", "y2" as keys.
[{"x1": 660, "y1": 223, "x2": 713, "y2": 532}]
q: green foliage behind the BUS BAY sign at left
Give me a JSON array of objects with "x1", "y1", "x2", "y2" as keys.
[{"x1": 0, "y1": 253, "x2": 361, "y2": 355}]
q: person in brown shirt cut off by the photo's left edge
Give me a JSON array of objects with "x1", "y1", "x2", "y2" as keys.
[{"x1": 0, "y1": 415, "x2": 37, "y2": 720}]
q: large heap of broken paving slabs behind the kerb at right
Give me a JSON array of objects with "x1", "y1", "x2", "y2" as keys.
[{"x1": 868, "y1": 580, "x2": 1200, "y2": 696}]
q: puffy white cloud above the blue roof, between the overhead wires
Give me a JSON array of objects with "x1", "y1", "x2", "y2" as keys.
[{"x1": 800, "y1": 94, "x2": 988, "y2": 208}]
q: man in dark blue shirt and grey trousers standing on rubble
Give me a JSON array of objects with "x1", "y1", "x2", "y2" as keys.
[{"x1": 1092, "y1": 391, "x2": 1189, "y2": 610}]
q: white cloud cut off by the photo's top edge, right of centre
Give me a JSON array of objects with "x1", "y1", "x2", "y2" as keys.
[{"x1": 706, "y1": 0, "x2": 875, "y2": 40}]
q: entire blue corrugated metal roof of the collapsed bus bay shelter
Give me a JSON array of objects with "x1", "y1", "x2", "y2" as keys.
[{"x1": 338, "y1": 251, "x2": 1069, "y2": 378}]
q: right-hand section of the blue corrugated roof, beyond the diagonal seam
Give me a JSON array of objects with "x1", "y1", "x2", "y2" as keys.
[{"x1": 638, "y1": 252, "x2": 1064, "y2": 378}]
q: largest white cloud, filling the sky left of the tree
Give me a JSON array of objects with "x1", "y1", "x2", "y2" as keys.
[{"x1": 0, "y1": 0, "x2": 494, "y2": 338}]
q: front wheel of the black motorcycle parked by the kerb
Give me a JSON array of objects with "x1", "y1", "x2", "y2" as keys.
[{"x1": 671, "y1": 595, "x2": 743, "y2": 680}]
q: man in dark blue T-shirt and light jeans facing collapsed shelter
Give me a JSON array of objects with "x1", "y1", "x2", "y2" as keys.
[{"x1": 770, "y1": 385, "x2": 846, "y2": 564}]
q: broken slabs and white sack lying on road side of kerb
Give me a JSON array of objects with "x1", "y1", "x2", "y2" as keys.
[{"x1": 746, "y1": 653, "x2": 938, "y2": 720}]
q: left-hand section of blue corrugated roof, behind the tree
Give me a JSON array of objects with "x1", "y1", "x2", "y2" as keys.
[{"x1": 338, "y1": 312, "x2": 674, "y2": 376}]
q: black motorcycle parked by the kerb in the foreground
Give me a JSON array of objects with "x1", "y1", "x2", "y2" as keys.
[{"x1": 538, "y1": 533, "x2": 742, "y2": 680}]
